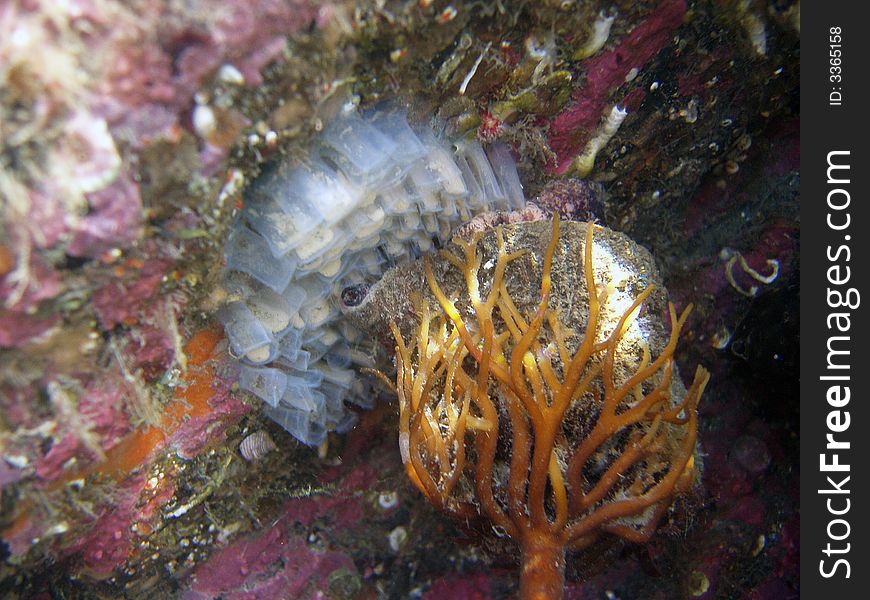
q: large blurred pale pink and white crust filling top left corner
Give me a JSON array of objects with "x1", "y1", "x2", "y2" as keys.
[{"x1": 0, "y1": 0, "x2": 317, "y2": 270}]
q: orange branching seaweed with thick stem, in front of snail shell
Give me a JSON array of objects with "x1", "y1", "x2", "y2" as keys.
[{"x1": 391, "y1": 220, "x2": 709, "y2": 598}]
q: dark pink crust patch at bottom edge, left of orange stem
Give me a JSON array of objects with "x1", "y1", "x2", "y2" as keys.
[{"x1": 181, "y1": 434, "x2": 386, "y2": 600}]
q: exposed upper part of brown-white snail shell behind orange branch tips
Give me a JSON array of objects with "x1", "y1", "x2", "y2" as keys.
[{"x1": 347, "y1": 220, "x2": 668, "y2": 355}]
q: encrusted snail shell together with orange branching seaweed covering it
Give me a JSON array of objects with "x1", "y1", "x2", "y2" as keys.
[{"x1": 352, "y1": 219, "x2": 709, "y2": 598}]
